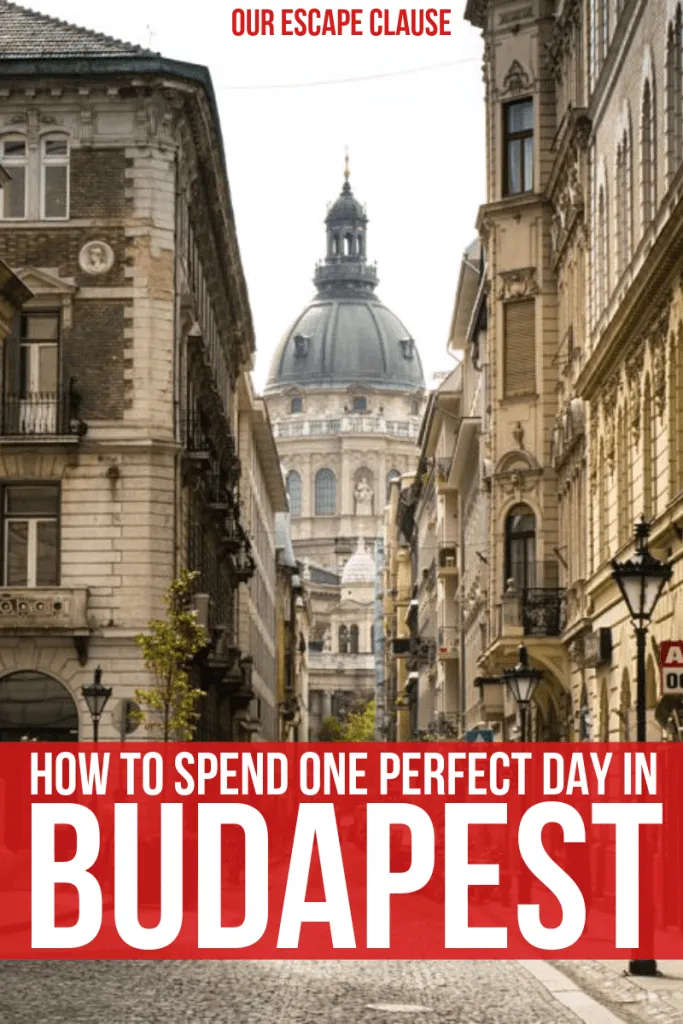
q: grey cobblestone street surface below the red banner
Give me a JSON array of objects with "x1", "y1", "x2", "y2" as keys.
[{"x1": 0, "y1": 961, "x2": 608, "y2": 1024}]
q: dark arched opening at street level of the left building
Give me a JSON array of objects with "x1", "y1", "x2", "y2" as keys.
[{"x1": 0, "y1": 672, "x2": 78, "y2": 742}]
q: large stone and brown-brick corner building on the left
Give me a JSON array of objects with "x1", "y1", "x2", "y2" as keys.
[{"x1": 0, "y1": 6, "x2": 260, "y2": 739}]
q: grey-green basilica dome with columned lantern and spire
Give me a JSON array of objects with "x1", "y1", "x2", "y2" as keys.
[{"x1": 265, "y1": 166, "x2": 425, "y2": 394}]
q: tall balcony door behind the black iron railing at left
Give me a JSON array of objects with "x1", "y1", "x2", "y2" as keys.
[{"x1": 4, "y1": 312, "x2": 59, "y2": 435}]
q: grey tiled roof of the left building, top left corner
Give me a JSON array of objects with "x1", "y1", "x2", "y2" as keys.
[{"x1": 0, "y1": 0, "x2": 157, "y2": 59}]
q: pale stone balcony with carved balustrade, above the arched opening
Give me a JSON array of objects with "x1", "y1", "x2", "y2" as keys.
[{"x1": 0, "y1": 587, "x2": 89, "y2": 635}]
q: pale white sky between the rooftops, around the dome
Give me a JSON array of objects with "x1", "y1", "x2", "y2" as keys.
[{"x1": 40, "y1": 0, "x2": 484, "y2": 387}]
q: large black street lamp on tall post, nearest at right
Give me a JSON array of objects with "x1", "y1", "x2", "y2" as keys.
[{"x1": 611, "y1": 516, "x2": 674, "y2": 977}]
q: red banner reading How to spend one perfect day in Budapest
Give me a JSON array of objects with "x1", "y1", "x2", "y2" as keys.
[{"x1": 0, "y1": 743, "x2": 683, "y2": 959}]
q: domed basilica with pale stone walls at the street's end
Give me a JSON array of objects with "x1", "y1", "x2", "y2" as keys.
[{"x1": 265, "y1": 168, "x2": 425, "y2": 738}]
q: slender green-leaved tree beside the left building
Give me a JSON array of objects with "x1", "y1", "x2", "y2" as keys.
[{"x1": 135, "y1": 569, "x2": 209, "y2": 742}]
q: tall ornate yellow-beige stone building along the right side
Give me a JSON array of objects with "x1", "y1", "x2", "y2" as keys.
[{"x1": 458, "y1": 0, "x2": 683, "y2": 740}]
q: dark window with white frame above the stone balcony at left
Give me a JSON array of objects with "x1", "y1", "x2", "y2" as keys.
[{"x1": 2, "y1": 484, "x2": 59, "y2": 587}]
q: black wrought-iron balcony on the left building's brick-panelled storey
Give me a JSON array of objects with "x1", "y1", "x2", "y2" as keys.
[{"x1": 0, "y1": 381, "x2": 87, "y2": 442}]
